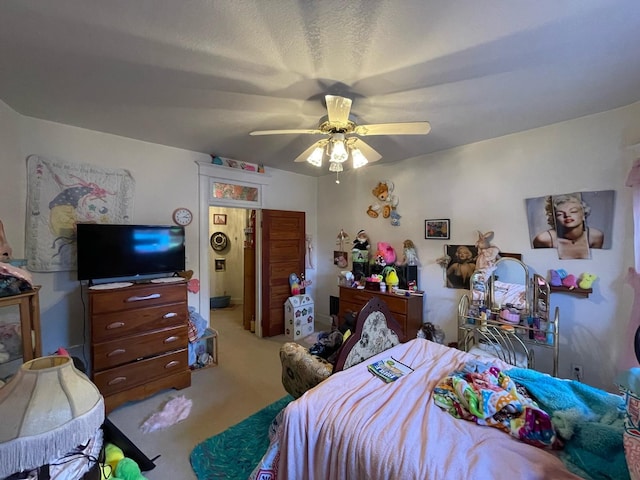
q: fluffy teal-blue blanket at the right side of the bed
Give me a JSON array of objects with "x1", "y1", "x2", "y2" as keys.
[{"x1": 507, "y1": 368, "x2": 629, "y2": 480}]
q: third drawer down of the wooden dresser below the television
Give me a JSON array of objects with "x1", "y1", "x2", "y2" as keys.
[{"x1": 92, "y1": 325, "x2": 188, "y2": 371}]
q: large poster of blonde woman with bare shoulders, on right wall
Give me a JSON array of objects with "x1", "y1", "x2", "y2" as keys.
[{"x1": 525, "y1": 190, "x2": 615, "y2": 260}]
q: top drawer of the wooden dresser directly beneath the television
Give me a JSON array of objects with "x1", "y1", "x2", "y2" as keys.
[{"x1": 89, "y1": 282, "x2": 187, "y2": 315}]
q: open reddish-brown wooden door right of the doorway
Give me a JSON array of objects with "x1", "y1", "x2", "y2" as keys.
[{"x1": 260, "y1": 210, "x2": 305, "y2": 337}]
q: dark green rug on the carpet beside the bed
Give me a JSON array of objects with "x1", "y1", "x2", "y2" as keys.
[{"x1": 190, "y1": 395, "x2": 293, "y2": 480}]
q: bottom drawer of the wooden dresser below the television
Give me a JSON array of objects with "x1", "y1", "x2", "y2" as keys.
[{"x1": 93, "y1": 348, "x2": 189, "y2": 396}]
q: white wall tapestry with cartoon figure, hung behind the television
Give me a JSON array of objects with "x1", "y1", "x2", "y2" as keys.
[{"x1": 25, "y1": 155, "x2": 135, "y2": 272}]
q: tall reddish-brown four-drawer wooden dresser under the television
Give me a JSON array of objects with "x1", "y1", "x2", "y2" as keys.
[{"x1": 89, "y1": 281, "x2": 191, "y2": 413}]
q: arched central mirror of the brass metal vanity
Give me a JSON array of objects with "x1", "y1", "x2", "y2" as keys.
[{"x1": 489, "y1": 257, "x2": 529, "y2": 314}]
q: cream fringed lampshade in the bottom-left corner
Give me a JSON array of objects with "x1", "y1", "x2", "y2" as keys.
[{"x1": 0, "y1": 356, "x2": 105, "y2": 478}]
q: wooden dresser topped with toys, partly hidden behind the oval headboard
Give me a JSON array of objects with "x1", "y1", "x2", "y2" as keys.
[{"x1": 338, "y1": 287, "x2": 423, "y2": 342}]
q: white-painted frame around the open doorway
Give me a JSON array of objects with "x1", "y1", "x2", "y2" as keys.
[{"x1": 196, "y1": 162, "x2": 271, "y2": 337}]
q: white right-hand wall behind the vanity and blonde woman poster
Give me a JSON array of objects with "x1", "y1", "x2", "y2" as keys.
[{"x1": 316, "y1": 103, "x2": 640, "y2": 390}]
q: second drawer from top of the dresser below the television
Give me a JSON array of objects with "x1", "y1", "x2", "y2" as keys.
[{"x1": 91, "y1": 303, "x2": 188, "y2": 343}]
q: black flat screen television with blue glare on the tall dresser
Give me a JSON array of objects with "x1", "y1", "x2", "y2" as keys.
[{"x1": 77, "y1": 223, "x2": 185, "y2": 281}]
